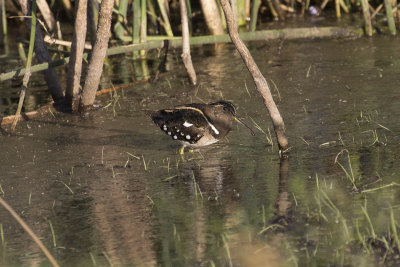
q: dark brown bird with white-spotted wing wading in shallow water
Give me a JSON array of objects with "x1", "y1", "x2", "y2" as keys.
[{"x1": 145, "y1": 100, "x2": 254, "y2": 155}]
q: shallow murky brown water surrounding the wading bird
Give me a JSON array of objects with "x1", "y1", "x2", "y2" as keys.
[{"x1": 0, "y1": 36, "x2": 400, "y2": 266}]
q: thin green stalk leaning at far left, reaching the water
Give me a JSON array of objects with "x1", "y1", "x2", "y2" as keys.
[{"x1": 11, "y1": 0, "x2": 36, "y2": 132}]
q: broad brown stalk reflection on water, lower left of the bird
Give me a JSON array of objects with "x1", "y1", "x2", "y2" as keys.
[{"x1": 90, "y1": 168, "x2": 156, "y2": 265}]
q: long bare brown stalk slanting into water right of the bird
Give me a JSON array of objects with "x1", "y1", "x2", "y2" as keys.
[{"x1": 220, "y1": 0, "x2": 289, "y2": 152}]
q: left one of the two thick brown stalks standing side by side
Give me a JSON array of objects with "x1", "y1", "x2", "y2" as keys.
[{"x1": 65, "y1": 0, "x2": 90, "y2": 111}]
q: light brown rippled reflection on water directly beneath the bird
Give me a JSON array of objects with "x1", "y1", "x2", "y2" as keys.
[{"x1": 176, "y1": 149, "x2": 250, "y2": 265}]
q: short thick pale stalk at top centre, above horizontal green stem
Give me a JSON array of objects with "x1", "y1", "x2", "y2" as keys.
[{"x1": 200, "y1": 0, "x2": 225, "y2": 35}]
